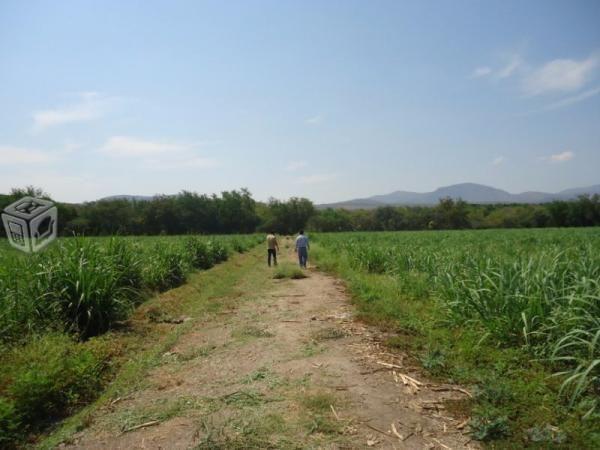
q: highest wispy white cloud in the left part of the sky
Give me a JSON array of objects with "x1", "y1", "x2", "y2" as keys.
[{"x1": 33, "y1": 92, "x2": 116, "y2": 132}]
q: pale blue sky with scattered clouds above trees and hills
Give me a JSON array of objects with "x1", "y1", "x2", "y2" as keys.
[{"x1": 0, "y1": 0, "x2": 600, "y2": 203}]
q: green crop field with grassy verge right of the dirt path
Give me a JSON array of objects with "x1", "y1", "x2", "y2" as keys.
[{"x1": 313, "y1": 228, "x2": 600, "y2": 448}]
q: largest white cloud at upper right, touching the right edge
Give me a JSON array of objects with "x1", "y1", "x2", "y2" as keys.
[{"x1": 522, "y1": 54, "x2": 600, "y2": 95}]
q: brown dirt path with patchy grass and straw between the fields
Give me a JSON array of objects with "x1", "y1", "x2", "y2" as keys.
[{"x1": 60, "y1": 241, "x2": 478, "y2": 449}]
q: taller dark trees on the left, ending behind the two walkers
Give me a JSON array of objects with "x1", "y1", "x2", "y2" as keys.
[{"x1": 0, "y1": 186, "x2": 315, "y2": 236}]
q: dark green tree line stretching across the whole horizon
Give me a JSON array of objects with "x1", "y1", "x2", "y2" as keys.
[{"x1": 0, "y1": 187, "x2": 600, "y2": 236}]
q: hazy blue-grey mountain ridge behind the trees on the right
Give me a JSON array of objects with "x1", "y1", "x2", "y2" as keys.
[{"x1": 317, "y1": 183, "x2": 600, "y2": 209}]
